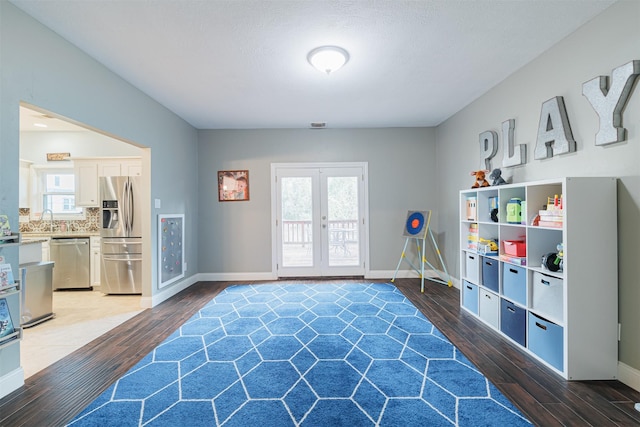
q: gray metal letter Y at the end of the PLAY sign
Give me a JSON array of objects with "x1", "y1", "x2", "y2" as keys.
[{"x1": 582, "y1": 61, "x2": 640, "y2": 145}]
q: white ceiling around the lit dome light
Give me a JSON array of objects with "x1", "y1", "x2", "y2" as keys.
[{"x1": 10, "y1": 0, "x2": 615, "y2": 129}]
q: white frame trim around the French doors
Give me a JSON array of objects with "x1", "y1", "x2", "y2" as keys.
[{"x1": 271, "y1": 162, "x2": 370, "y2": 277}]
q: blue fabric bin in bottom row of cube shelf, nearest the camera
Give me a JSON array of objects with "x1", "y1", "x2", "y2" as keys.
[{"x1": 529, "y1": 313, "x2": 564, "y2": 371}]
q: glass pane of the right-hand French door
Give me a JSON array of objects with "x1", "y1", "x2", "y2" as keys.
[{"x1": 327, "y1": 176, "x2": 360, "y2": 266}]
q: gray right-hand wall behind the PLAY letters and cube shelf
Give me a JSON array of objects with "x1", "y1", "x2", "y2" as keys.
[{"x1": 436, "y1": 1, "x2": 640, "y2": 369}]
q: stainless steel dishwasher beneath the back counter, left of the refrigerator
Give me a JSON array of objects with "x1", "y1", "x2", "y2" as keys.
[{"x1": 50, "y1": 237, "x2": 92, "y2": 289}]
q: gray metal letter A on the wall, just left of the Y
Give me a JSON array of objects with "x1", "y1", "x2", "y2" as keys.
[{"x1": 533, "y1": 96, "x2": 576, "y2": 160}]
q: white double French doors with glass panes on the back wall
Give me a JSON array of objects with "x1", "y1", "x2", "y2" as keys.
[{"x1": 271, "y1": 163, "x2": 368, "y2": 277}]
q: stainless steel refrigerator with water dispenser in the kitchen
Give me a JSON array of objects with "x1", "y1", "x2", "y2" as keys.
[{"x1": 100, "y1": 176, "x2": 142, "y2": 294}]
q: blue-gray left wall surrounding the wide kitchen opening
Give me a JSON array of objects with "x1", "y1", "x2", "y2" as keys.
[{"x1": 0, "y1": 1, "x2": 199, "y2": 297}]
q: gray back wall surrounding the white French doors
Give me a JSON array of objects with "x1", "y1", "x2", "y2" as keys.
[{"x1": 198, "y1": 128, "x2": 438, "y2": 273}]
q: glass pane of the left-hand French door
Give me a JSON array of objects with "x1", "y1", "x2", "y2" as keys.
[{"x1": 280, "y1": 177, "x2": 313, "y2": 267}]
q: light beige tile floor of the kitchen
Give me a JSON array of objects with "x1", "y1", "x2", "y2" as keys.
[{"x1": 20, "y1": 290, "x2": 143, "y2": 378}]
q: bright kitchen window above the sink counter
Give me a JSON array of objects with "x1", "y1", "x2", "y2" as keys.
[{"x1": 31, "y1": 168, "x2": 85, "y2": 220}]
